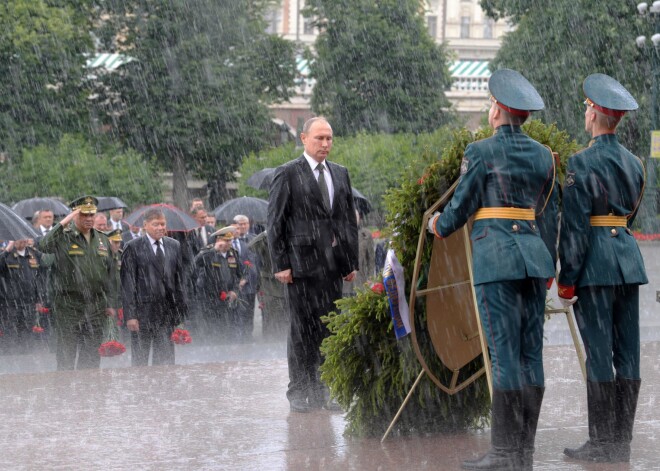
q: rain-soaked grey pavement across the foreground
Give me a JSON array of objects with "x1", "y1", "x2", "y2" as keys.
[{"x1": 0, "y1": 244, "x2": 660, "y2": 471}]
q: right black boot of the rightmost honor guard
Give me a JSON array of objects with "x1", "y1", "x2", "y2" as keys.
[{"x1": 610, "y1": 377, "x2": 642, "y2": 463}]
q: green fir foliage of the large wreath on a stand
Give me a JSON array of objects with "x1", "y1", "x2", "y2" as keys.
[{"x1": 321, "y1": 120, "x2": 578, "y2": 437}]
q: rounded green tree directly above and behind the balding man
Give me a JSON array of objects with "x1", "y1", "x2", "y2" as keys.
[{"x1": 305, "y1": 0, "x2": 451, "y2": 135}]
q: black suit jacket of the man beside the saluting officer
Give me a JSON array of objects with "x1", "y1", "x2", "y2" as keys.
[{"x1": 121, "y1": 235, "x2": 187, "y2": 326}]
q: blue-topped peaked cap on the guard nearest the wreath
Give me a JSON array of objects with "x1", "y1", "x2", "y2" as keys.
[{"x1": 488, "y1": 69, "x2": 545, "y2": 116}]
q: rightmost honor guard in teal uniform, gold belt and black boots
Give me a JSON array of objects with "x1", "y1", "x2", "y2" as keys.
[{"x1": 558, "y1": 74, "x2": 648, "y2": 462}]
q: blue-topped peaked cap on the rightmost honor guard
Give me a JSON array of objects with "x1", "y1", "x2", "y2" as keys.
[{"x1": 582, "y1": 74, "x2": 639, "y2": 117}]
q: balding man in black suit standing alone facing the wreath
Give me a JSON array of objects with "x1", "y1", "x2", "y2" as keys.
[{"x1": 268, "y1": 118, "x2": 358, "y2": 412}]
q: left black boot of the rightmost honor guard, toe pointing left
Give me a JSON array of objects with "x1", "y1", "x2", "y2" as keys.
[{"x1": 564, "y1": 381, "x2": 616, "y2": 463}]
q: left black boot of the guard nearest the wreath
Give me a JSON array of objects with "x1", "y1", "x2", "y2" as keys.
[{"x1": 463, "y1": 389, "x2": 523, "y2": 470}]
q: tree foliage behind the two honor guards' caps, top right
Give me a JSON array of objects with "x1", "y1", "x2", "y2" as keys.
[{"x1": 481, "y1": 0, "x2": 653, "y2": 155}]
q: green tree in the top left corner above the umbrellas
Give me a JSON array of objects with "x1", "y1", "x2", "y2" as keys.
[{"x1": 0, "y1": 0, "x2": 92, "y2": 158}]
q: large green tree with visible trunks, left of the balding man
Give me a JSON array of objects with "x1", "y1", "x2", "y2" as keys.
[{"x1": 106, "y1": 0, "x2": 295, "y2": 210}]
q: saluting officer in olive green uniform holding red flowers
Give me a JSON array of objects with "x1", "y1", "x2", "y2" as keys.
[{"x1": 39, "y1": 196, "x2": 117, "y2": 370}]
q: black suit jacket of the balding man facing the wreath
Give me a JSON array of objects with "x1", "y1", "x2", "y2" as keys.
[{"x1": 268, "y1": 156, "x2": 358, "y2": 278}]
